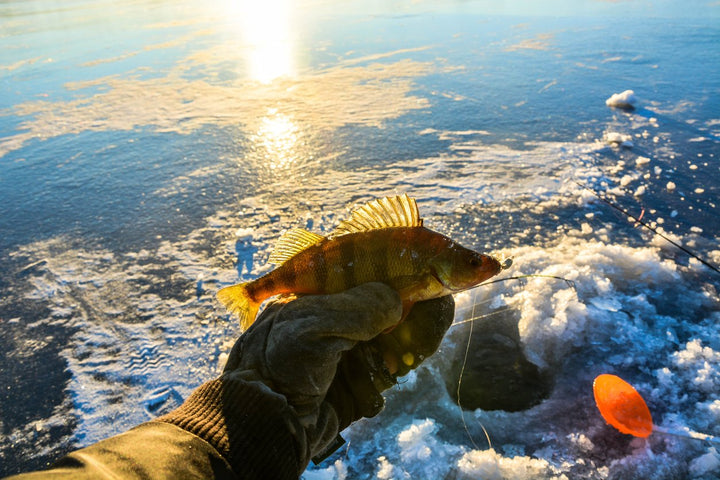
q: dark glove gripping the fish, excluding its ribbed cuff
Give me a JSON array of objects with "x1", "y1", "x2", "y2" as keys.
[{"x1": 223, "y1": 283, "x2": 454, "y2": 463}]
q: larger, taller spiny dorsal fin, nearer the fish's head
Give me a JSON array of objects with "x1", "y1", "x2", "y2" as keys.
[{"x1": 333, "y1": 194, "x2": 422, "y2": 236}]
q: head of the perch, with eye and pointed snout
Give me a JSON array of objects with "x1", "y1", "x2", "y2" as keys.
[{"x1": 430, "y1": 243, "x2": 502, "y2": 292}]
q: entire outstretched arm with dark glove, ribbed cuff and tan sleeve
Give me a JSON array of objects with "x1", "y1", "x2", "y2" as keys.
[{"x1": 7, "y1": 283, "x2": 454, "y2": 480}]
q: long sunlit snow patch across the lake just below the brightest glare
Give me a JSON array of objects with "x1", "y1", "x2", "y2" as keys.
[{"x1": 0, "y1": 52, "x2": 435, "y2": 157}]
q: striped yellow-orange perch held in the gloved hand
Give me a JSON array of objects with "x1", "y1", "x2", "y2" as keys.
[{"x1": 217, "y1": 195, "x2": 508, "y2": 330}]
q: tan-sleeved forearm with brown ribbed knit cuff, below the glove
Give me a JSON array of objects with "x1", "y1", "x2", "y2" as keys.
[{"x1": 8, "y1": 376, "x2": 308, "y2": 480}]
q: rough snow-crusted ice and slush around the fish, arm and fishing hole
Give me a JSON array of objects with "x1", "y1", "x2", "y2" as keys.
[{"x1": 4, "y1": 131, "x2": 720, "y2": 480}]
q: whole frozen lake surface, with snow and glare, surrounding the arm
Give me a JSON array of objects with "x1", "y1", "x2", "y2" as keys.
[{"x1": 0, "y1": 1, "x2": 720, "y2": 480}]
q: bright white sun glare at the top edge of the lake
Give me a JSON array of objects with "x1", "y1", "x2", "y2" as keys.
[{"x1": 226, "y1": 0, "x2": 295, "y2": 83}]
